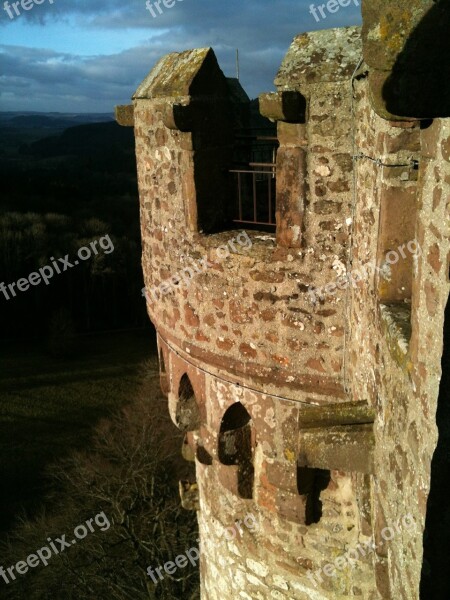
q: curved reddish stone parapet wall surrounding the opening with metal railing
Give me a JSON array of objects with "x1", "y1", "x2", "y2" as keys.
[{"x1": 134, "y1": 37, "x2": 366, "y2": 402}]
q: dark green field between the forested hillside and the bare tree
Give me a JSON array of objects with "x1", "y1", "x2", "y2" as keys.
[{"x1": 0, "y1": 328, "x2": 158, "y2": 533}]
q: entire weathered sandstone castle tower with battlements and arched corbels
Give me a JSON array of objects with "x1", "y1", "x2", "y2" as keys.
[{"x1": 117, "y1": 0, "x2": 450, "y2": 600}]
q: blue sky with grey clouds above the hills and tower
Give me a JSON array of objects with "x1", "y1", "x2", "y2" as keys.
[{"x1": 0, "y1": 0, "x2": 361, "y2": 113}]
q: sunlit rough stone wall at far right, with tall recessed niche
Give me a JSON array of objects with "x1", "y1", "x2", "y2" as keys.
[{"x1": 348, "y1": 72, "x2": 450, "y2": 599}]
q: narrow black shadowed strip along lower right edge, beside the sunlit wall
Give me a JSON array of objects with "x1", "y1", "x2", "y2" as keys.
[{"x1": 420, "y1": 300, "x2": 450, "y2": 600}]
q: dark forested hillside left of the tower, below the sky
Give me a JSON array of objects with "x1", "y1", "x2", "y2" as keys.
[{"x1": 0, "y1": 114, "x2": 146, "y2": 339}]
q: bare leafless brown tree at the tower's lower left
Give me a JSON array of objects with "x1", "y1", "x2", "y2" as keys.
[{"x1": 0, "y1": 364, "x2": 199, "y2": 600}]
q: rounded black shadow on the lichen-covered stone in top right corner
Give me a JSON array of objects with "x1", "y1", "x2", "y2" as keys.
[{"x1": 383, "y1": 0, "x2": 450, "y2": 118}]
